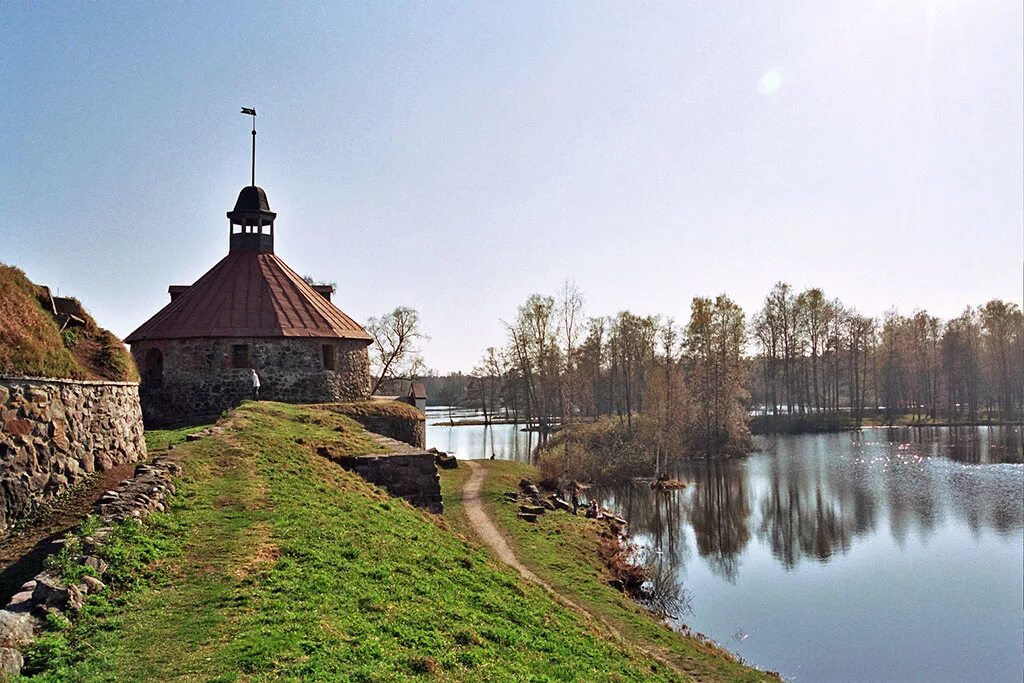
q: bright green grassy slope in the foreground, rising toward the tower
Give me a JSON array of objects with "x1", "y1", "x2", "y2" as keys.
[{"x1": 18, "y1": 403, "x2": 729, "y2": 681}]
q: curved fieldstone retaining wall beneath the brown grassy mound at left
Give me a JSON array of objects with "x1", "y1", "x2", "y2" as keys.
[{"x1": 0, "y1": 377, "x2": 145, "y2": 530}]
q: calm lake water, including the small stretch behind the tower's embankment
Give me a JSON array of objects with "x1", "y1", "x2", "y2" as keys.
[{"x1": 427, "y1": 414, "x2": 1024, "y2": 681}]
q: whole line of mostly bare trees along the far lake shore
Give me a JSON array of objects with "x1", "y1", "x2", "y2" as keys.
[{"x1": 436, "y1": 283, "x2": 1024, "y2": 455}]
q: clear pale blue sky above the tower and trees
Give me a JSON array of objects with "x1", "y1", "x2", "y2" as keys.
[{"x1": 0, "y1": 0, "x2": 1024, "y2": 372}]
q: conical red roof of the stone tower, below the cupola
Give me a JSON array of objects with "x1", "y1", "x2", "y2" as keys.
[{"x1": 125, "y1": 251, "x2": 372, "y2": 344}]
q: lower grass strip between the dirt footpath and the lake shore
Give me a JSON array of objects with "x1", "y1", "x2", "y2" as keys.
[{"x1": 441, "y1": 461, "x2": 777, "y2": 681}]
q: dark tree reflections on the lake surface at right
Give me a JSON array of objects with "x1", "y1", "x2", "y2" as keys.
[{"x1": 591, "y1": 428, "x2": 1024, "y2": 583}]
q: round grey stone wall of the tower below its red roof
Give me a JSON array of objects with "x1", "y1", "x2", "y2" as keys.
[{"x1": 131, "y1": 337, "x2": 370, "y2": 425}]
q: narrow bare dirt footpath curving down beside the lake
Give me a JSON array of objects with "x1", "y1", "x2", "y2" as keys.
[{"x1": 460, "y1": 460, "x2": 692, "y2": 680}]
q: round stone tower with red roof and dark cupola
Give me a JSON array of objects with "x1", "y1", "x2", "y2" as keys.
[{"x1": 125, "y1": 185, "x2": 372, "y2": 425}]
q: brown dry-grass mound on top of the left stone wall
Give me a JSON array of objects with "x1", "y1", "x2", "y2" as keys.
[{"x1": 0, "y1": 263, "x2": 138, "y2": 381}]
